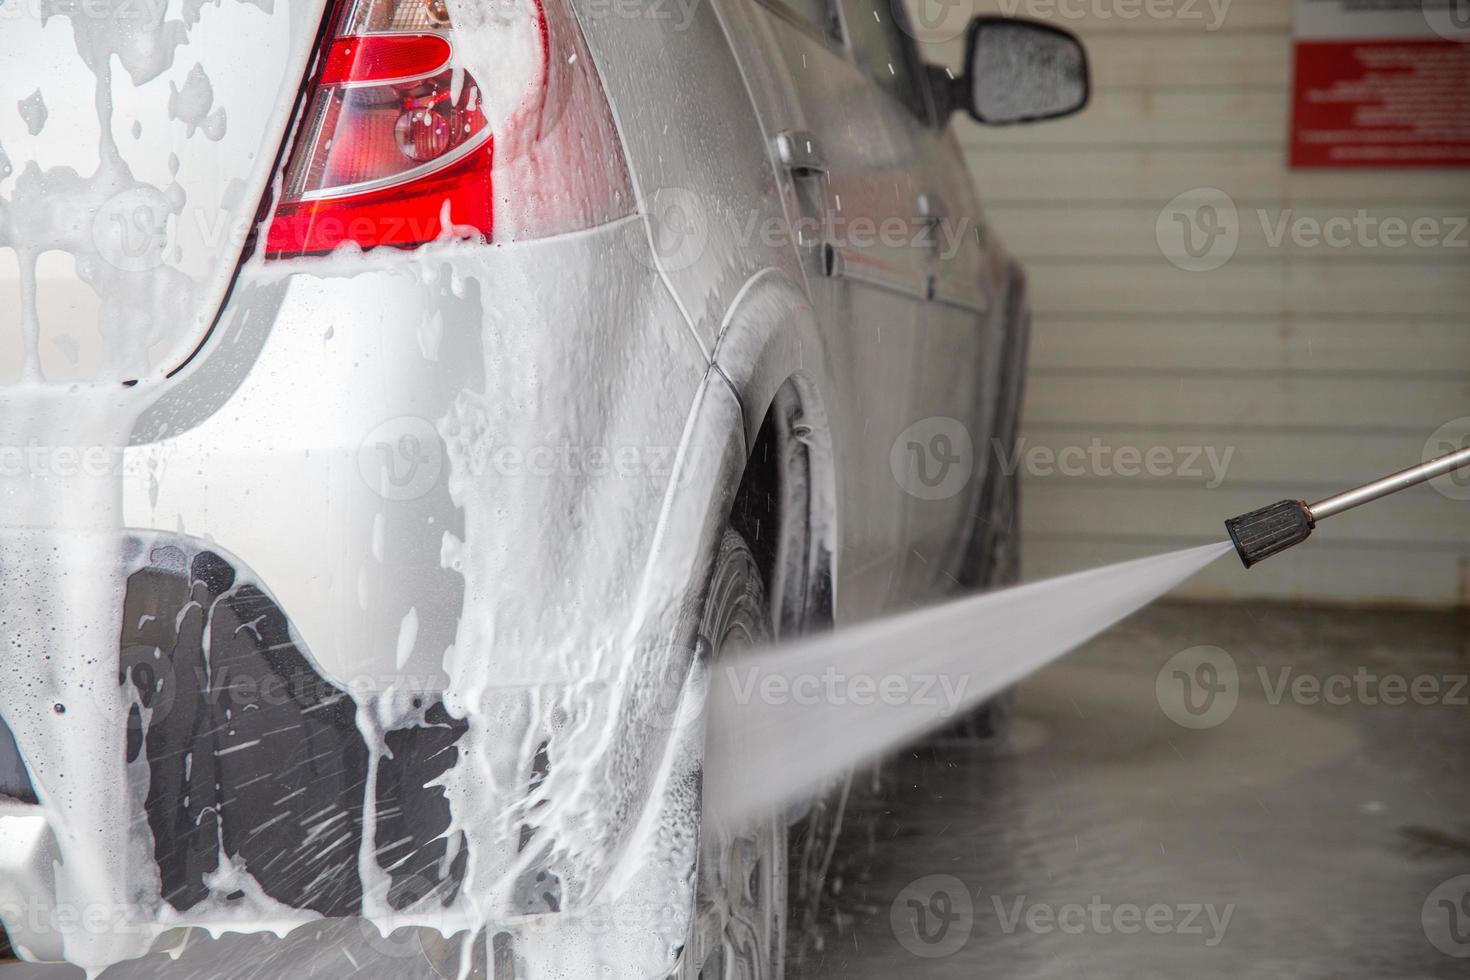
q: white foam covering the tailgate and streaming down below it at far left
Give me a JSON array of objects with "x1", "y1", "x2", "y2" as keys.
[{"x1": 0, "y1": 0, "x2": 319, "y2": 974}]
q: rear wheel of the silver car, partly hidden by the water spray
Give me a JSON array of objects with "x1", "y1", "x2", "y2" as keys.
[{"x1": 678, "y1": 530, "x2": 788, "y2": 980}]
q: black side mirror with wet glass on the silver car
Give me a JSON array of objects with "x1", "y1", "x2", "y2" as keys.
[{"x1": 936, "y1": 18, "x2": 1092, "y2": 126}]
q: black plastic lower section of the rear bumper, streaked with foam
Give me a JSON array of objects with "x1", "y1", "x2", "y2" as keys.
[{"x1": 0, "y1": 535, "x2": 467, "y2": 959}]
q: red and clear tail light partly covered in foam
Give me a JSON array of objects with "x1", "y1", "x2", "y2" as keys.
[{"x1": 266, "y1": 0, "x2": 632, "y2": 259}]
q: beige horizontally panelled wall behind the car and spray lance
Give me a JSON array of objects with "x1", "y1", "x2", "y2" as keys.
[{"x1": 914, "y1": 0, "x2": 1470, "y2": 605}]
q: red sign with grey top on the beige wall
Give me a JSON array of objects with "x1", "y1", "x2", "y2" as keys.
[{"x1": 1291, "y1": 0, "x2": 1470, "y2": 167}]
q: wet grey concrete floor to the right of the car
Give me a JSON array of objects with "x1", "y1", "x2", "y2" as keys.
[{"x1": 791, "y1": 604, "x2": 1470, "y2": 980}]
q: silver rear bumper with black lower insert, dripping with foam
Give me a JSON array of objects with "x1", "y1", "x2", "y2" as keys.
[{"x1": 0, "y1": 219, "x2": 723, "y2": 976}]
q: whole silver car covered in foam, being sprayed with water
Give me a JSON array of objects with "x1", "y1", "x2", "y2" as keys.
[{"x1": 0, "y1": 0, "x2": 1088, "y2": 980}]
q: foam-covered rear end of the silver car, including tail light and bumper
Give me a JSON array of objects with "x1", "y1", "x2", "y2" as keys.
[{"x1": 0, "y1": 0, "x2": 707, "y2": 974}]
